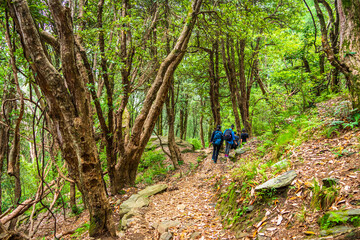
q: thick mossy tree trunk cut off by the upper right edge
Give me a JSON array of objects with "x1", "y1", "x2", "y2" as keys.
[{"x1": 314, "y1": 0, "x2": 360, "y2": 103}]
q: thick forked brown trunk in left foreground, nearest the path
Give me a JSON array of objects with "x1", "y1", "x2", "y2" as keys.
[{"x1": 8, "y1": 0, "x2": 115, "y2": 236}]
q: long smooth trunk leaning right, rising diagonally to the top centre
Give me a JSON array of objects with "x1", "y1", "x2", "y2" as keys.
[{"x1": 116, "y1": 0, "x2": 202, "y2": 189}]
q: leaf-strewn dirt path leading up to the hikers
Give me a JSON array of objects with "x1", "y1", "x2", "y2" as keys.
[{"x1": 121, "y1": 149, "x2": 235, "y2": 240}]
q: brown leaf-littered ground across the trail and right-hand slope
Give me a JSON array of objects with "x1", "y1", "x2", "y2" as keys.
[{"x1": 34, "y1": 99, "x2": 360, "y2": 240}]
